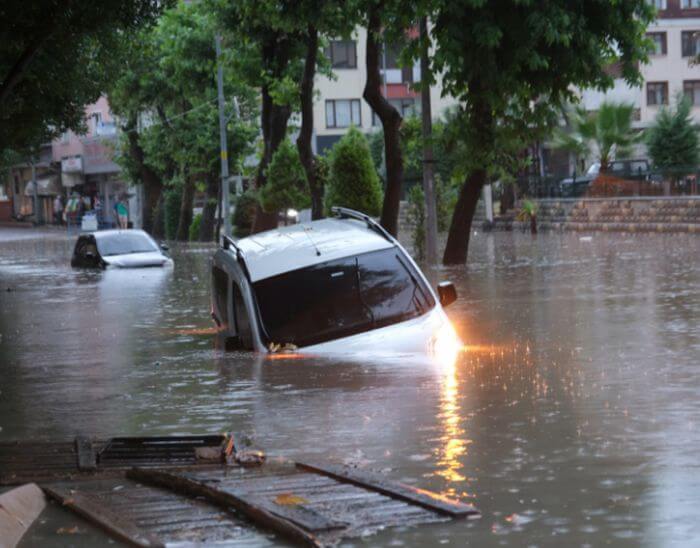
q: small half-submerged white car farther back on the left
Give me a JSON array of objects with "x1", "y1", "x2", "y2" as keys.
[{"x1": 70, "y1": 229, "x2": 173, "y2": 268}]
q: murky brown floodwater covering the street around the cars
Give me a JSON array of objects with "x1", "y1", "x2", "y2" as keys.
[{"x1": 0, "y1": 229, "x2": 700, "y2": 546}]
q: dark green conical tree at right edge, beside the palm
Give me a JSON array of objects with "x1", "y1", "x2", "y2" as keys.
[{"x1": 646, "y1": 96, "x2": 700, "y2": 178}]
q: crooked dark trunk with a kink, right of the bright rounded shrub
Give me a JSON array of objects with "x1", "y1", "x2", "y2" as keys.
[{"x1": 362, "y1": 6, "x2": 403, "y2": 236}]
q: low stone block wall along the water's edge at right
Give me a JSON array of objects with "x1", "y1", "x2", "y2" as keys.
[{"x1": 493, "y1": 196, "x2": 700, "y2": 234}]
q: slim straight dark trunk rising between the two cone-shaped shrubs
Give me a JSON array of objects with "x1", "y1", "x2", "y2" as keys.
[{"x1": 297, "y1": 25, "x2": 323, "y2": 220}]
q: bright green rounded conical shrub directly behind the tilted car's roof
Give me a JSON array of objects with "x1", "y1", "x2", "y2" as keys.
[{"x1": 325, "y1": 127, "x2": 382, "y2": 216}]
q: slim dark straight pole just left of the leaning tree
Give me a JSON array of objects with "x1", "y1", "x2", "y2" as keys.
[{"x1": 420, "y1": 17, "x2": 437, "y2": 265}]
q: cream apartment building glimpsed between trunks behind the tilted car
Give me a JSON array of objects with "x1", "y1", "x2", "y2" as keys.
[{"x1": 314, "y1": 27, "x2": 454, "y2": 152}]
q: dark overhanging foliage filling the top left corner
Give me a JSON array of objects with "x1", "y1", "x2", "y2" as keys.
[{"x1": 0, "y1": 0, "x2": 167, "y2": 152}]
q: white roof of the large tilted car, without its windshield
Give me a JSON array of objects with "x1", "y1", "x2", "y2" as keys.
[{"x1": 236, "y1": 219, "x2": 394, "y2": 282}]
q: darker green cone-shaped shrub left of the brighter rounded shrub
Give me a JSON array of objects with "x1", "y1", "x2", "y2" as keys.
[{"x1": 260, "y1": 139, "x2": 311, "y2": 213}]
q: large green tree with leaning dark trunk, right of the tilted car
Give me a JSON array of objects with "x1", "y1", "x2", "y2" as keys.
[{"x1": 414, "y1": 0, "x2": 655, "y2": 264}]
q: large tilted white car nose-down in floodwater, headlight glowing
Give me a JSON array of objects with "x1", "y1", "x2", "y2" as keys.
[{"x1": 212, "y1": 208, "x2": 461, "y2": 354}]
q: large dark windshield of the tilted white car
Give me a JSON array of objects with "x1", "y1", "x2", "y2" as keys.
[{"x1": 253, "y1": 248, "x2": 435, "y2": 346}]
